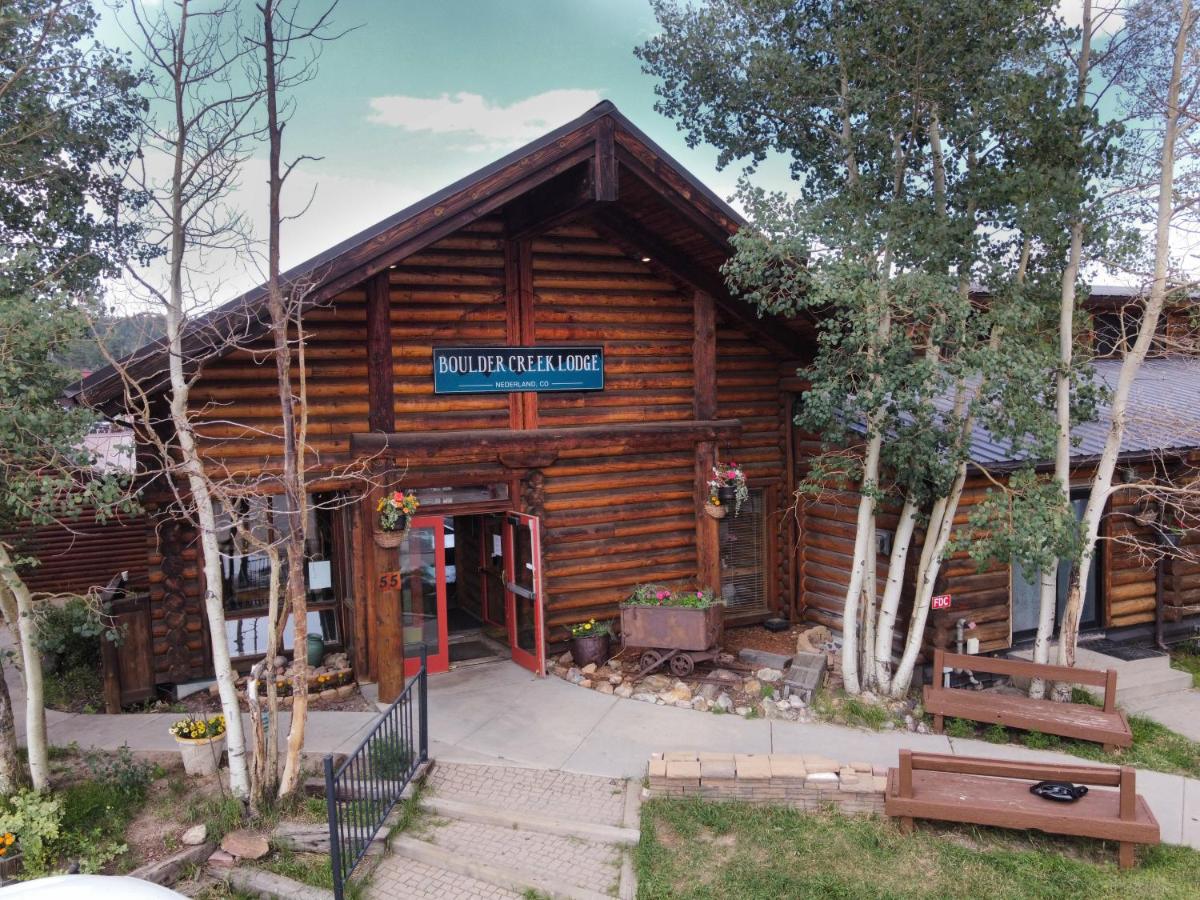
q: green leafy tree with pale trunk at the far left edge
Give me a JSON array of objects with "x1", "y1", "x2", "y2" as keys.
[{"x1": 0, "y1": 0, "x2": 143, "y2": 790}]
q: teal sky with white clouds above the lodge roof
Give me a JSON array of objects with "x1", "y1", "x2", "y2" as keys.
[{"x1": 100, "y1": 0, "x2": 1132, "y2": 305}]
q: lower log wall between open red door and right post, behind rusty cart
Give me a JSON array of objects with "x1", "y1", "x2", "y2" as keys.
[{"x1": 542, "y1": 448, "x2": 696, "y2": 641}]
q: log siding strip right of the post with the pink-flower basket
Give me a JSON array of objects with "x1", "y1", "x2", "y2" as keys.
[{"x1": 716, "y1": 317, "x2": 796, "y2": 611}]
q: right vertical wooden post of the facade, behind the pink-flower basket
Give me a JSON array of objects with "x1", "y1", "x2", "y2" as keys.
[{"x1": 691, "y1": 290, "x2": 721, "y2": 592}]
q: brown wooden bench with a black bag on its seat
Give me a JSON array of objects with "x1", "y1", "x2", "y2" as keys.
[{"x1": 883, "y1": 750, "x2": 1159, "y2": 869}]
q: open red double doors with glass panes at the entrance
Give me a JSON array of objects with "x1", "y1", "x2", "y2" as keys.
[{"x1": 397, "y1": 512, "x2": 545, "y2": 677}]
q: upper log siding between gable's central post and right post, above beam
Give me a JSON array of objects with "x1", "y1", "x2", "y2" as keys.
[{"x1": 533, "y1": 226, "x2": 692, "y2": 428}]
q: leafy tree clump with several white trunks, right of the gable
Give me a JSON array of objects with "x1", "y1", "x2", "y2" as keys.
[{"x1": 638, "y1": 0, "x2": 1113, "y2": 695}]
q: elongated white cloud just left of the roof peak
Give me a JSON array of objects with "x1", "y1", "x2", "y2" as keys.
[{"x1": 368, "y1": 89, "x2": 601, "y2": 151}]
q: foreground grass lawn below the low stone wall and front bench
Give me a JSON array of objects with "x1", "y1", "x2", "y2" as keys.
[{"x1": 635, "y1": 799, "x2": 1200, "y2": 900}]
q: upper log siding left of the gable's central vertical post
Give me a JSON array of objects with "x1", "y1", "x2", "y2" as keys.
[{"x1": 192, "y1": 220, "x2": 509, "y2": 473}]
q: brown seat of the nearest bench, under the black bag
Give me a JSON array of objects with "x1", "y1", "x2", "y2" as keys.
[{"x1": 884, "y1": 769, "x2": 1159, "y2": 844}]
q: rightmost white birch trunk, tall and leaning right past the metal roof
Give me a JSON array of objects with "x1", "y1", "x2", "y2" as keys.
[{"x1": 1058, "y1": 0, "x2": 1192, "y2": 676}]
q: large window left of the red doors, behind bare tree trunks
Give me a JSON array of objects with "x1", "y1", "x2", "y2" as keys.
[{"x1": 216, "y1": 494, "x2": 341, "y2": 658}]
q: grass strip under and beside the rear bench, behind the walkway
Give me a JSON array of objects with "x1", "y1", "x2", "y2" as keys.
[{"x1": 946, "y1": 689, "x2": 1200, "y2": 778}]
